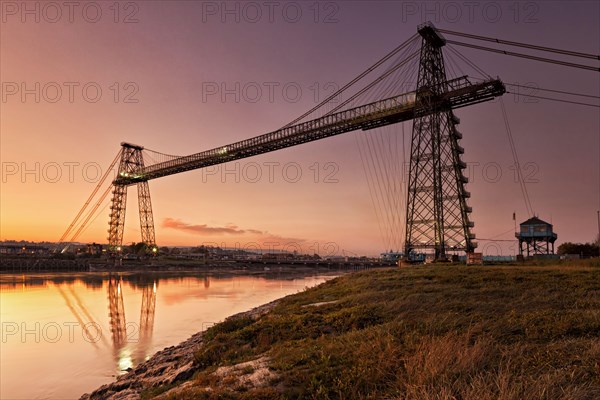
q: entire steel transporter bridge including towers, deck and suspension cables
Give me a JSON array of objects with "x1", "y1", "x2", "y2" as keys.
[{"x1": 57, "y1": 23, "x2": 600, "y2": 259}]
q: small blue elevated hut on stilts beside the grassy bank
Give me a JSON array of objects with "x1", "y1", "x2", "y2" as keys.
[{"x1": 515, "y1": 217, "x2": 558, "y2": 257}]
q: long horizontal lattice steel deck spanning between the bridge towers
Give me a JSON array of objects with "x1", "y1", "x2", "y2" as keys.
[{"x1": 113, "y1": 77, "x2": 505, "y2": 185}]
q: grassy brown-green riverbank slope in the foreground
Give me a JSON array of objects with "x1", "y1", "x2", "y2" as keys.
[{"x1": 144, "y1": 264, "x2": 600, "y2": 400}]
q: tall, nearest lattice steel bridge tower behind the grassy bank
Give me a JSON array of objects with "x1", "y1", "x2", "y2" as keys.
[{"x1": 405, "y1": 23, "x2": 476, "y2": 260}]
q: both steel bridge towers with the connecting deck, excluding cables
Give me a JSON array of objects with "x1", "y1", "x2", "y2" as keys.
[{"x1": 102, "y1": 23, "x2": 506, "y2": 259}]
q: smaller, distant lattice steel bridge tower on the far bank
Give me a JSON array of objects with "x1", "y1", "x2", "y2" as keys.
[{"x1": 108, "y1": 142, "x2": 156, "y2": 252}]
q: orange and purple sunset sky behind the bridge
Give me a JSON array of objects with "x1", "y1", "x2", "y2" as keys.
[{"x1": 0, "y1": 1, "x2": 600, "y2": 255}]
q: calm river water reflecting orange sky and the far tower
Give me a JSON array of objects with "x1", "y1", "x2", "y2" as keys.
[{"x1": 0, "y1": 272, "x2": 334, "y2": 399}]
